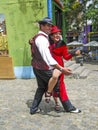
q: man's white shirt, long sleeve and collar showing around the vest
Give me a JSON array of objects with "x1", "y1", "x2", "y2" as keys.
[{"x1": 35, "y1": 31, "x2": 58, "y2": 69}]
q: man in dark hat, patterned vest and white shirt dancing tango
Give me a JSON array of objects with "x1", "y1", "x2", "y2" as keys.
[{"x1": 29, "y1": 17, "x2": 78, "y2": 114}]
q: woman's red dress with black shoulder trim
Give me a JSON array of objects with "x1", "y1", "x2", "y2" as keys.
[{"x1": 50, "y1": 41, "x2": 72, "y2": 101}]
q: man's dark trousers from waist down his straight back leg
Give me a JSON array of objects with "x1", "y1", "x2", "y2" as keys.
[{"x1": 31, "y1": 68, "x2": 53, "y2": 111}]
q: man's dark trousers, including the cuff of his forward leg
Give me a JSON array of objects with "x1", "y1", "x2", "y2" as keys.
[{"x1": 30, "y1": 68, "x2": 73, "y2": 113}]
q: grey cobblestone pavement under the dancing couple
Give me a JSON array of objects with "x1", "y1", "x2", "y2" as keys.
[{"x1": 0, "y1": 64, "x2": 98, "y2": 130}]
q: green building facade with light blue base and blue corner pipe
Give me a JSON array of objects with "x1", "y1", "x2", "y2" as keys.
[{"x1": 0, "y1": 0, "x2": 63, "y2": 78}]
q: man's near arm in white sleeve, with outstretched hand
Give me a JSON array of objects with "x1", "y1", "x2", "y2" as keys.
[{"x1": 36, "y1": 36, "x2": 72, "y2": 75}]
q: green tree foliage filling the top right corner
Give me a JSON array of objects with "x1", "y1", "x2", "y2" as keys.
[{"x1": 64, "y1": 0, "x2": 98, "y2": 31}]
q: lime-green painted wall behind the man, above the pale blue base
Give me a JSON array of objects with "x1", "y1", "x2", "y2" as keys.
[{"x1": 0, "y1": 0, "x2": 47, "y2": 66}]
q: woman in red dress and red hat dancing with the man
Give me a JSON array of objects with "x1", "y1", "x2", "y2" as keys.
[{"x1": 45, "y1": 26, "x2": 80, "y2": 113}]
